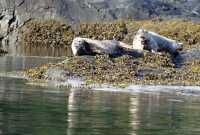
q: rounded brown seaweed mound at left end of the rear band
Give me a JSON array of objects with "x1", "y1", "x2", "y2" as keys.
[{"x1": 20, "y1": 20, "x2": 74, "y2": 47}]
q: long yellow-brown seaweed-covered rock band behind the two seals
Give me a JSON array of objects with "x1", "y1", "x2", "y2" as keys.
[{"x1": 20, "y1": 19, "x2": 200, "y2": 50}]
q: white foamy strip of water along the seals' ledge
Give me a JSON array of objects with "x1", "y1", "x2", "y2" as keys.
[{"x1": 0, "y1": 72, "x2": 200, "y2": 96}]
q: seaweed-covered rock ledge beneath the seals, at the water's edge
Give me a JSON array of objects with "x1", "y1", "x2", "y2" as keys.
[{"x1": 26, "y1": 54, "x2": 200, "y2": 86}]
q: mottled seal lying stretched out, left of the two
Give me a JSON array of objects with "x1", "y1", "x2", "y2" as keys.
[{"x1": 71, "y1": 37, "x2": 140, "y2": 56}]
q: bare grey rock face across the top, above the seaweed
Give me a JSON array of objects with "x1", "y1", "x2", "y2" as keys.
[{"x1": 0, "y1": 0, "x2": 200, "y2": 54}]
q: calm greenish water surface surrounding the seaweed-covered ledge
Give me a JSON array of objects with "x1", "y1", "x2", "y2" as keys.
[{"x1": 0, "y1": 57, "x2": 200, "y2": 135}]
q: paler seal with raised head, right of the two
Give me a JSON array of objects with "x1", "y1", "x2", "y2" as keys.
[{"x1": 133, "y1": 29, "x2": 182, "y2": 55}]
